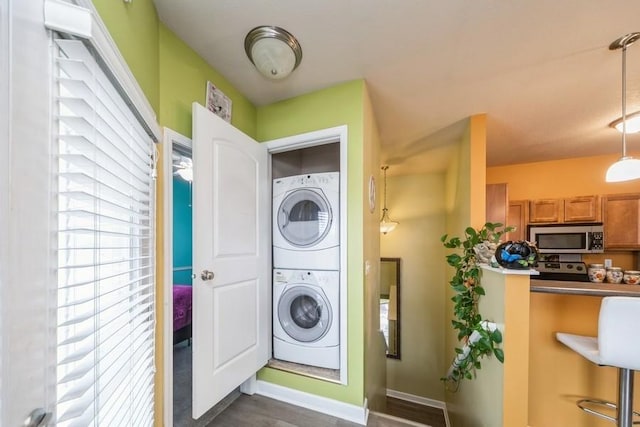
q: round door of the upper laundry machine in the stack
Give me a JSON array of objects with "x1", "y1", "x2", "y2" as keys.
[{"x1": 278, "y1": 188, "x2": 333, "y2": 248}]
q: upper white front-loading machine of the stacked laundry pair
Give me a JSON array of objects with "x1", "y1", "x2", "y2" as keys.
[{"x1": 273, "y1": 172, "x2": 340, "y2": 270}]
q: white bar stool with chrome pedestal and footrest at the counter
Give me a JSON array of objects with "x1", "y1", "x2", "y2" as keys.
[{"x1": 556, "y1": 297, "x2": 640, "y2": 427}]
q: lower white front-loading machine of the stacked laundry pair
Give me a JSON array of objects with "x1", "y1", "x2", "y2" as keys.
[{"x1": 273, "y1": 269, "x2": 340, "y2": 369}]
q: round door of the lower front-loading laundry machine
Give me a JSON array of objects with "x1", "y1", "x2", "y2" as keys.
[{"x1": 278, "y1": 286, "x2": 332, "y2": 342}]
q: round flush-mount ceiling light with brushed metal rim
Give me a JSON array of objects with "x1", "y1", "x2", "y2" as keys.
[{"x1": 244, "y1": 25, "x2": 302, "y2": 80}]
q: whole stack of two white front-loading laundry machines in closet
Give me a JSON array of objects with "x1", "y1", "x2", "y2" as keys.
[{"x1": 273, "y1": 172, "x2": 340, "y2": 369}]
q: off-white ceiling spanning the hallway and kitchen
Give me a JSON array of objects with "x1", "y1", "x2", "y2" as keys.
[{"x1": 154, "y1": 0, "x2": 640, "y2": 175}]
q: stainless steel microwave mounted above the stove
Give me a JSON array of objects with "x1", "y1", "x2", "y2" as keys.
[{"x1": 529, "y1": 223, "x2": 604, "y2": 254}]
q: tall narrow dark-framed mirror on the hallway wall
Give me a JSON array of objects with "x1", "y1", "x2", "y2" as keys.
[{"x1": 380, "y1": 258, "x2": 400, "y2": 359}]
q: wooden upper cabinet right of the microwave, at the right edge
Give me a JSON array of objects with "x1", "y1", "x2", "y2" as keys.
[{"x1": 602, "y1": 193, "x2": 640, "y2": 250}]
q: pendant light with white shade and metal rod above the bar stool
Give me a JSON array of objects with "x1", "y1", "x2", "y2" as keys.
[{"x1": 606, "y1": 33, "x2": 640, "y2": 182}]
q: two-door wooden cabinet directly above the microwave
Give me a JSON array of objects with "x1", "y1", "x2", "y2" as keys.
[{"x1": 529, "y1": 196, "x2": 602, "y2": 224}]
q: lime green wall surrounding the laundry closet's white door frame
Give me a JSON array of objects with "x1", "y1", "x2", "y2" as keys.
[{"x1": 257, "y1": 80, "x2": 365, "y2": 406}]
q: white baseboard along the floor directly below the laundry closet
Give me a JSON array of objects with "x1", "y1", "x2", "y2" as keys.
[{"x1": 256, "y1": 380, "x2": 369, "y2": 426}]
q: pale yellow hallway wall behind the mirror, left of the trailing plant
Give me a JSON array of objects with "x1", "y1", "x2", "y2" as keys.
[{"x1": 380, "y1": 169, "x2": 448, "y2": 401}]
